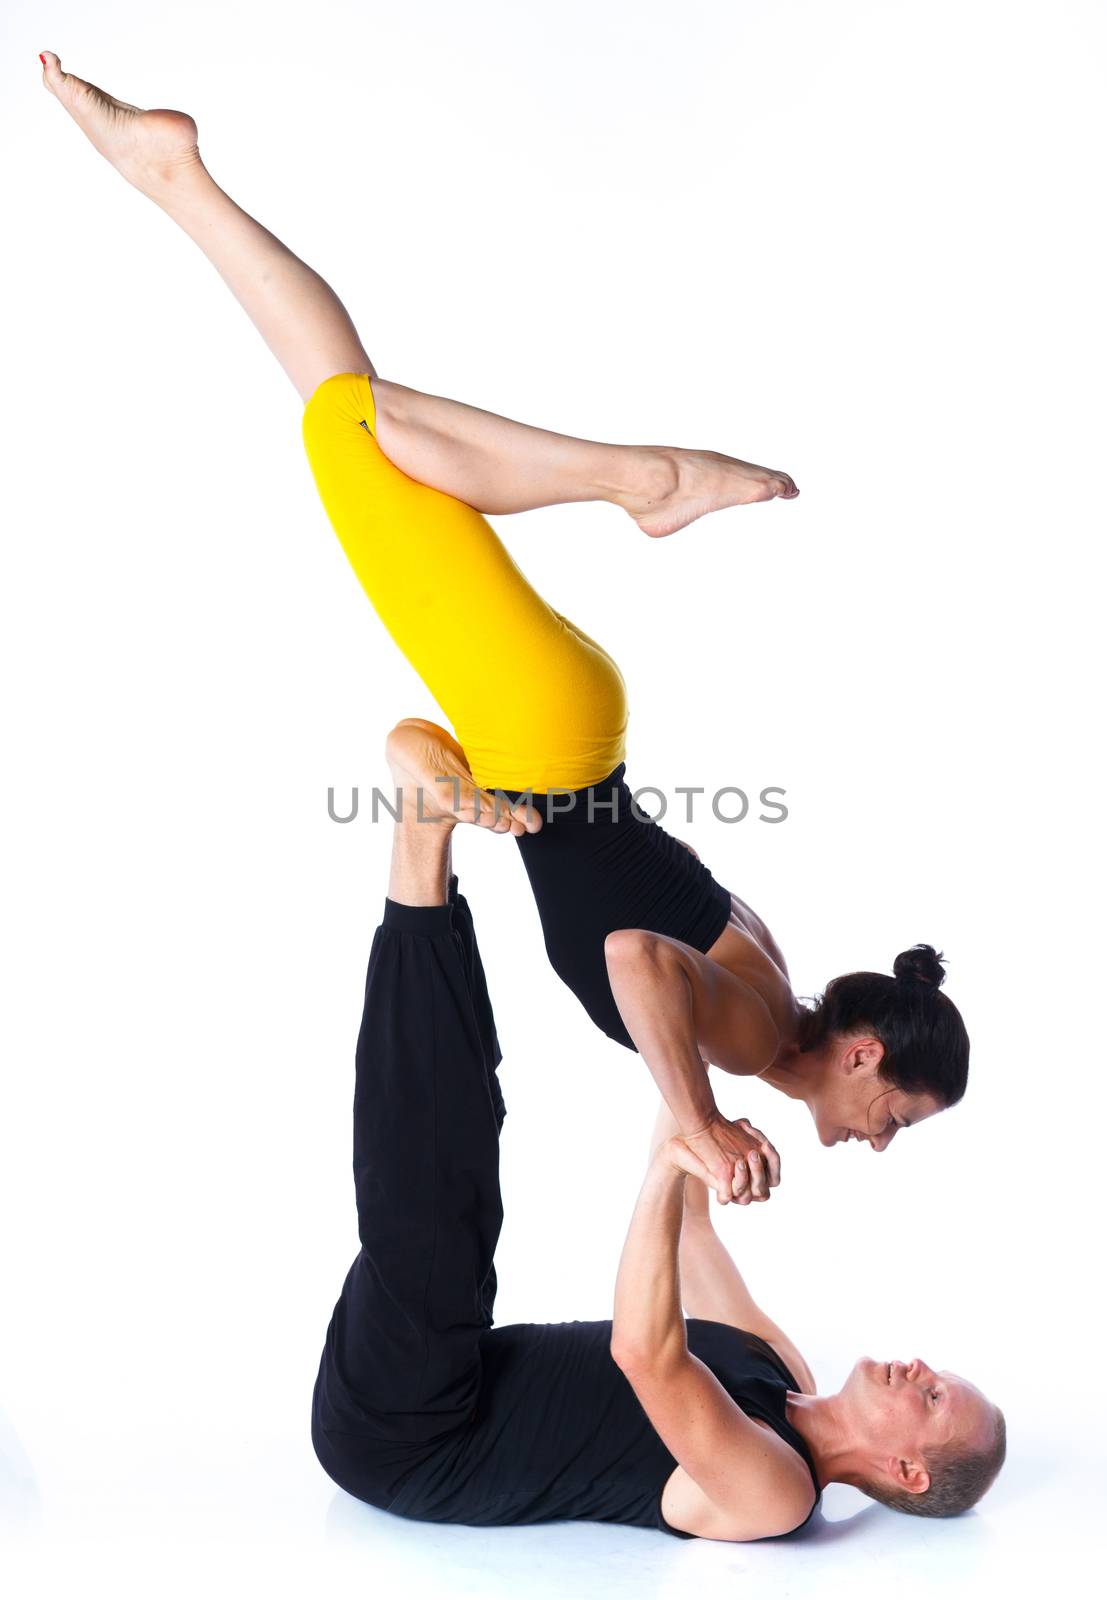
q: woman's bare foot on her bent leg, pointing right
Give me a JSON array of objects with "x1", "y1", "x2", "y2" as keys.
[{"x1": 617, "y1": 446, "x2": 800, "y2": 539}]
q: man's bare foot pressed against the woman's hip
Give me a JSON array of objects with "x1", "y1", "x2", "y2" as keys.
[{"x1": 384, "y1": 717, "x2": 542, "y2": 837}]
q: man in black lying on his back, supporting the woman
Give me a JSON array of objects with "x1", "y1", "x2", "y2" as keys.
[{"x1": 312, "y1": 768, "x2": 1005, "y2": 1539}]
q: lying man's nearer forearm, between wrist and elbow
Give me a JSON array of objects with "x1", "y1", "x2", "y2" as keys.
[{"x1": 611, "y1": 1158, "x2": 688, "y2": 1370}]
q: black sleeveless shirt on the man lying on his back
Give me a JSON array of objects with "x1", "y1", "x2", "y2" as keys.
[{"x1": 387, "y1": 1317, "x2": 819, "y2": 1538}]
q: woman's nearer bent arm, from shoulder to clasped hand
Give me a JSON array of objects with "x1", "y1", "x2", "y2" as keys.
[{"x1": 605, "y1": 928, "x2": 781, "y2": 1203}]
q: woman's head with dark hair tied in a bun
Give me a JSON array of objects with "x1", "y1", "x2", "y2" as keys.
[{"x1": 798, "y1": 944, "x2": 969, "y2": 1150}]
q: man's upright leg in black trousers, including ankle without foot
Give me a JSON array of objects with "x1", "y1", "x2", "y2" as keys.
[{"x1": 312, "y1": 806, "x2": 502, "y2": 1504}]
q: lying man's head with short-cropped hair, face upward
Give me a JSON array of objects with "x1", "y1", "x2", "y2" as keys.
[{"x1": 838, "y1": 1357, "x2": 1006, "y2": 1517}]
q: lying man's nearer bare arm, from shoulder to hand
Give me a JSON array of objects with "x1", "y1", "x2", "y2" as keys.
[{"x1": 611, "y1": 1139, "x2": 814, "y2": 1539}]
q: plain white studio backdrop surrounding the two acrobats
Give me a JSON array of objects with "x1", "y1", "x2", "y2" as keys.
[{"x1": 0, "y1": 0, "x2": 1105, "y2": 1597}]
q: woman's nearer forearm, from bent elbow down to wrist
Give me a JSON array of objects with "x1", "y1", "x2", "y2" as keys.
[{"x1": 605, "y1": 930, "x2": 718, "y2": 1136}]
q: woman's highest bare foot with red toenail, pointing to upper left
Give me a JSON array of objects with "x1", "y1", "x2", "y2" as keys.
[{"x1": 42, "y1": 50, "x2": 202, "y2": 194}]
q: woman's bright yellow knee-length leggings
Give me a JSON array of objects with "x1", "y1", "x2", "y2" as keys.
[{"x1": 302, "y1": 373, "x2": 627, "y2": 794}]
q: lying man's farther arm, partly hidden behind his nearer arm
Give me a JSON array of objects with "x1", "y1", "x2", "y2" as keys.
[{"x1": 649, "y1": 1102, "x2": 816, "y2": 1395}]
